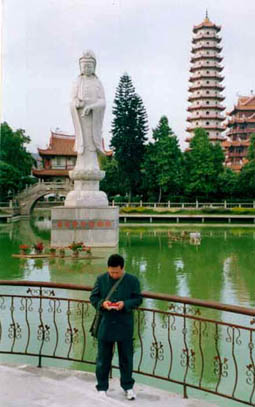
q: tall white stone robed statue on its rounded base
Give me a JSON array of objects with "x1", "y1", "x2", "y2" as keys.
[{"x1": 65, "y1": 51, "x2": 108, "y2": 207}]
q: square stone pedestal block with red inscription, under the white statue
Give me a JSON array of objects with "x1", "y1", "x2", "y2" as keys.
[{"x1": 51, "y1": 206, "x2": 119, "y2": 247}]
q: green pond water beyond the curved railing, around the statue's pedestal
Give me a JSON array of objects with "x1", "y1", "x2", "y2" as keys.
[{"x1": 0, "y1": 213, "x2": 255, "y2": 406}]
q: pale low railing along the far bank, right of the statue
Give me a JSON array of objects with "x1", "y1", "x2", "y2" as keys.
[{"x1": 110, "y1": 200, "x2": 255, "y2": 209}]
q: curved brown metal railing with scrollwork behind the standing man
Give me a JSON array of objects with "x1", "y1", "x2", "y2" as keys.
[{"x1": 0, "y1": 281, "x2": 255, "y2": 406}]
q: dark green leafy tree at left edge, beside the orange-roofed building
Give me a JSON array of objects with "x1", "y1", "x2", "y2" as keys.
[{"x1": 0, "y1": 122, "x2": 36, "y2": 200}]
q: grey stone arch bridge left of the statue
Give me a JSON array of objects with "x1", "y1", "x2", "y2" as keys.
[{"x1": 15, "y1": 179, "x2": 73, "y2": 216}]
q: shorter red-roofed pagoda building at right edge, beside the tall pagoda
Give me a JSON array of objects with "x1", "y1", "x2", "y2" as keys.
[{"x1": 222, "y1": 95, "x2": 255, "y2": 171}]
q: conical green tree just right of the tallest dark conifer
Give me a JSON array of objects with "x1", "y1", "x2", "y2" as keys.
[{"x1": 143, "y1": 116, "x2": 183, "y2": 202}]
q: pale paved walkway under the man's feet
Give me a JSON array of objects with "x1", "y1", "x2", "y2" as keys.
[{"x1": 0, "y1": 365, "x2": 217, "y2": 407}]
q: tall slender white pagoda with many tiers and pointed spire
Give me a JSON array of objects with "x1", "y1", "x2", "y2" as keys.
[{"x1": 186, "y1": 12, "x2": 225, "y2": 146}]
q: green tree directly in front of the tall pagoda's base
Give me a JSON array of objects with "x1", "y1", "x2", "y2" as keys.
[{"x1": 185, "y1": 128, "x2": 224, "y2": 198}]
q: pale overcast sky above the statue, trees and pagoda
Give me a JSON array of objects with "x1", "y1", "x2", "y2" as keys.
[{"x1": 1, "y1": 0, "x2": 255, "y2": 152}]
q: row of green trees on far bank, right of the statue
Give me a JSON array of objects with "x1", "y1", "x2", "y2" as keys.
[{"x1": 101, "y1": 74, "x2": 255, "y2": 202}]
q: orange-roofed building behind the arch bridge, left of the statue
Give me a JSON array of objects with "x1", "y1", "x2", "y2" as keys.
[{"x1": 33, "y1": 132, "x2": 77, "y2": 182}]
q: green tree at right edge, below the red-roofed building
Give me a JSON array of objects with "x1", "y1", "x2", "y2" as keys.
[{"x1": 239, "y1": 134, "x2": 255, "y2": 198}]
